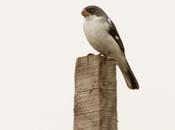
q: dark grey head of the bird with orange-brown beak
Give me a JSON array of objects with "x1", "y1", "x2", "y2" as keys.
[{"x1": 81, "y1": 5, "x2": 108, "y2": 18}]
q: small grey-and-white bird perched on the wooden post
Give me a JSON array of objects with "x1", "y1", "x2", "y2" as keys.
[{"x1": 81, "y1": 5, "x2": 139, "y2": 90}]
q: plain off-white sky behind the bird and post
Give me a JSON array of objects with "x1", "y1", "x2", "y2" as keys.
[{"x1": 0, "y1": 0, "x2": 175, "y2": 130}]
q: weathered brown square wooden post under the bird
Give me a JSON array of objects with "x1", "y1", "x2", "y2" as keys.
[{"x1": 74, "y1": 55, "x2": 117, "y2": 130}]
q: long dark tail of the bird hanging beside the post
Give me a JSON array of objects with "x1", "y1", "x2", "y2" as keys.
[{"x1": 119, "y1": 60, "x2": 139, "y2": 89}]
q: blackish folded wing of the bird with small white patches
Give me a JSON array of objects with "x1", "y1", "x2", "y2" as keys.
[{"x1": 107, "y1": 19, "x2": 125, "y2": 54}]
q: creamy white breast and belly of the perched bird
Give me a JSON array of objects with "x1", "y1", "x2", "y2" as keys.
[{"x1": 84, "y1": 18, "x2": 121, "y2": 57}]
